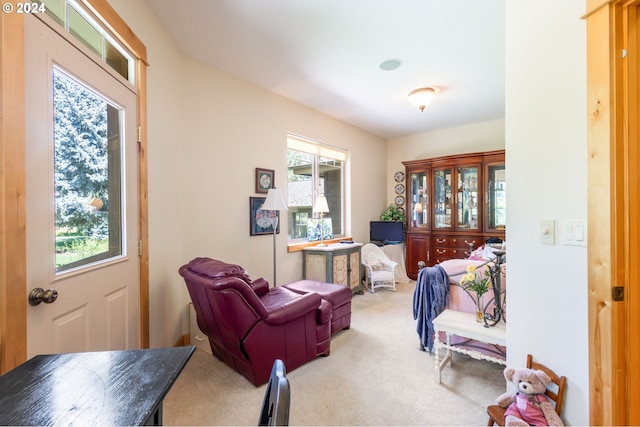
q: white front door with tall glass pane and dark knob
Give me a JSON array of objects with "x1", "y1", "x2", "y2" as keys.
[{"x1": 25, "y1": 15, "x2": 139, "y2": 357}]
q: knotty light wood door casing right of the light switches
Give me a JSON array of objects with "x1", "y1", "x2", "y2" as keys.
[{"x1": 587, "y1": 3, "x2": 619, "y2": 425}]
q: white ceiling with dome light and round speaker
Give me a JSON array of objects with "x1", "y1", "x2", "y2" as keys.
[{"x1": 145, "y1": 0, "x2": 506, "y2": 138}]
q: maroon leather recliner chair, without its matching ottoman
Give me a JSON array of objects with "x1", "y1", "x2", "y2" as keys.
[{"x1": 179, "y1": 258, "x2": 332, "y2": 386}]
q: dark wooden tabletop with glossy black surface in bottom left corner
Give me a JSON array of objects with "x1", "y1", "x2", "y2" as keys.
[{"x1": 0, "y1": 346, "x2": 195, "y2": 426}]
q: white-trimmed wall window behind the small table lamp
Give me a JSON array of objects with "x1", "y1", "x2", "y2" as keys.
[{"x1": 287, "y1": 134, "x2": 348, "y2": 243}]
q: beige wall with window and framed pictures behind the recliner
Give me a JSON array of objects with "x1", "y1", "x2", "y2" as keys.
[{"x1": 110, "y1": 0, "x2": 386, "y2": 347}]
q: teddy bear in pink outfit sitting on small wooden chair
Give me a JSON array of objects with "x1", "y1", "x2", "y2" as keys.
[{"x1": 496, "y1": 368, "x2": 564, "y2": 426}]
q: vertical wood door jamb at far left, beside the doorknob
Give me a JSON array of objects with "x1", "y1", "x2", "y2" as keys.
[{"x1": 0, "y1": 13, "x2": 27, "y2": 374}]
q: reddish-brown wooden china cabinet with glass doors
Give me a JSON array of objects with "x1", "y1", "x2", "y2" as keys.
[{"x1": 402, "y1": 150, "x2": 506, "y2": 280}]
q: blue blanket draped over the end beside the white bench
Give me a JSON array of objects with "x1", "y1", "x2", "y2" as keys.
[{"x1": 413, "y1": 265, "x2": 449, "y2": 353}]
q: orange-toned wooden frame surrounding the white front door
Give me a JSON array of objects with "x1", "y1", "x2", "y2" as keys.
[{"x1": 0, "y1": 0, "x2": 149, "y2": 374}]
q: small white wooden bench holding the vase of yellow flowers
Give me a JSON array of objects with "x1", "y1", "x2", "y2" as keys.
[{"x1": 433, "y1": 310, "x2": 507, "y2": 384}]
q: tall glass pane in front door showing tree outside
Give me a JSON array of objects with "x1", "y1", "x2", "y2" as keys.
[{"x1": 53, "y1": 69, "x2": 122, "y2": 271}]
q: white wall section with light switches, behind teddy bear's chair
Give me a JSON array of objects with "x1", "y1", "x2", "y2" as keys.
[{"x1": 505, "y1": 0, "x2": 592, "y2": 425}]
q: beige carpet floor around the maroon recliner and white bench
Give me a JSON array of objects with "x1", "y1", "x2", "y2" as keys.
[{"x1": 164, "y1": 282, "x2": 506, "y2": 426}]
